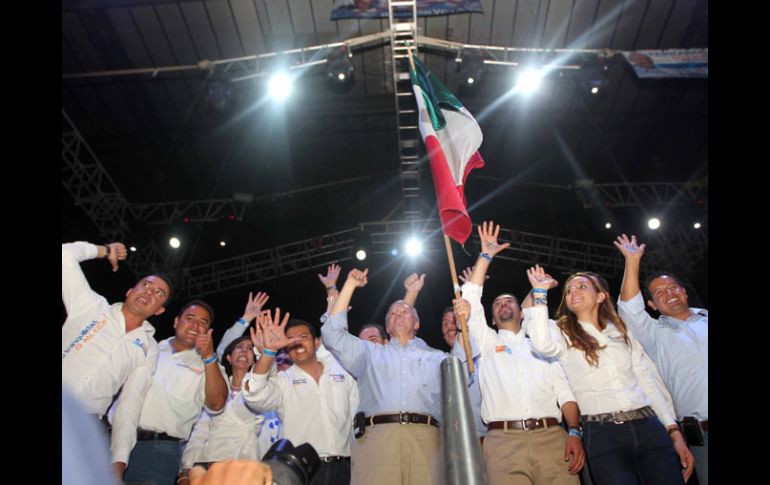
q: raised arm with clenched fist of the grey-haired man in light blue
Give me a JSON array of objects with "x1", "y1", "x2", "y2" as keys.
[{"x1": 321, "y1": 269, "x2": 375, "y2": 378}]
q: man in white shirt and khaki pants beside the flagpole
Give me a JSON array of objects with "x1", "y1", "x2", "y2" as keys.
[{"x1": 462, "y1": 222, "x2": 585, "y2": 485}]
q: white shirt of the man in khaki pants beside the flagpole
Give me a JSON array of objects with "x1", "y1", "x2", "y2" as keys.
[{"x1": 463, "y1": 283, "x2": 575, "y2": 423}]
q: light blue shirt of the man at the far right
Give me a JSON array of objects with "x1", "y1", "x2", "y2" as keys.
[{"x1": 618, "y1": 293, "x2": 709, "y2": 420}]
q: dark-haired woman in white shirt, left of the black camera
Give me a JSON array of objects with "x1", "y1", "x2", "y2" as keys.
[{"x1": 177, "y1": 335, "x2": 280, "y2": 485}]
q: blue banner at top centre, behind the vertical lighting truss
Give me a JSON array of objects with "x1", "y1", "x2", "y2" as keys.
[{"x1": 332, "y1": 0, "x2": 483, "y2": 20}]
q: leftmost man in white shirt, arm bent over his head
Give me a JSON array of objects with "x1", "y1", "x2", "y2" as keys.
[{"x1": 62, "y1": 242, "x2": 171, "y2": 419}]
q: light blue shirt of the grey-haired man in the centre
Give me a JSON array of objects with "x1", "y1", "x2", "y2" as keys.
[{"x1": 321, "y1": 312, "x2": 449, "y2": 422}]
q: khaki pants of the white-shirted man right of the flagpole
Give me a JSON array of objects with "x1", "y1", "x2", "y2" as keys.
[{"x1": 483, "y1": 426, "x2": 579, "y2": 485}]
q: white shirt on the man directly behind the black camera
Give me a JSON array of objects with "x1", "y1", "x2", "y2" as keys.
[{"x1": 241, "y1": 355, "x2": 358, "y2": 457}]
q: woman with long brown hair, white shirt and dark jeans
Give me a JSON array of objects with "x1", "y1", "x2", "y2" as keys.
[{"x1": 524, "y1": 266, "x2": 694, "y2": 485}]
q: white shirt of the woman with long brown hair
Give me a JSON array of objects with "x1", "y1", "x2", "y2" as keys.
[{"x1": 524, "y1": 305, "x2": 675, "y2": 426}]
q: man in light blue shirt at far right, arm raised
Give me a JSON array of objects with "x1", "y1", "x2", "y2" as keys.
[{"x1": 614, "y1": 234, "x2": 709, "y2": 485}]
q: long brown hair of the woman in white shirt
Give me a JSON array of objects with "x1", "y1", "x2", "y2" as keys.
[{"x1": 556, "y1": 271, "x2": 631, "y2": 367}]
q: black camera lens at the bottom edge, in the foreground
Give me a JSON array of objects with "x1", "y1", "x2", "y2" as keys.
[{"x1": 262, "y1": 439, "x2": 321, "y2": 485}]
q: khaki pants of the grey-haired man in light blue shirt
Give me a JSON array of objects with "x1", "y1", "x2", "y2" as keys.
[{"x1": 350, "y1": 423, "x2": 444, "y2": 485}]
